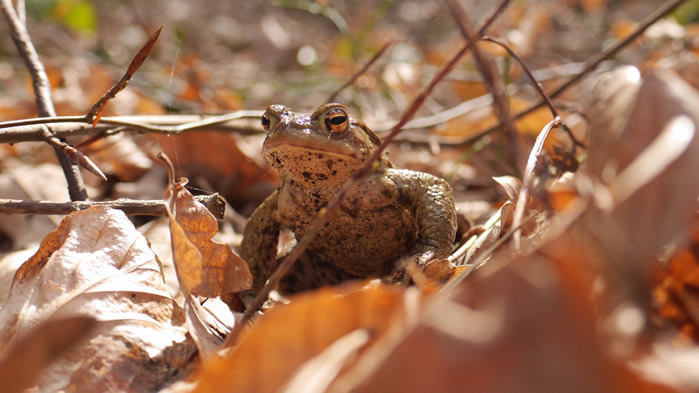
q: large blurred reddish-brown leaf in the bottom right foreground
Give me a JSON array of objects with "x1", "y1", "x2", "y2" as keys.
[{"x1": 338, "y1": 248, "x2": 667, "y2": 393}]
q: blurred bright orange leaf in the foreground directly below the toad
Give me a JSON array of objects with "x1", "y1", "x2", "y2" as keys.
[{"x1": 191, "y1": 284, "x2": 419, "y2": 393}]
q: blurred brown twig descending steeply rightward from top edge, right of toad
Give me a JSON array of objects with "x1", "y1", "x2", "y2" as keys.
[{"x1": 447, "y1": 0, "x2": 519, "y2": 169}]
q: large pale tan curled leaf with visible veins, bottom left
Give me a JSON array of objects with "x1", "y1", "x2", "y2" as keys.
[{"x1": 0, "y1": 207, "x2": 196, "y2": 392}]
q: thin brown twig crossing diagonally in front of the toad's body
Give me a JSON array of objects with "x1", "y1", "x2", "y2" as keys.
[{"x1": 224, "y1": 0, "x2": 509, "y2": 346}]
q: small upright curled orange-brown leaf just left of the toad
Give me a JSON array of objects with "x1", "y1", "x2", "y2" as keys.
[{"x1": 166, "y1": 176, "x2": 252, "y2": 297}]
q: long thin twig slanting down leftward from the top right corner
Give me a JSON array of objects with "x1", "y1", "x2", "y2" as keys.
[{"x1": 460, "y1": 0, "x2": 687, "y2": 145}]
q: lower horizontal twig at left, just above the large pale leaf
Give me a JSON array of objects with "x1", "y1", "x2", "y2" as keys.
[{"x1": 0, "y1": 194, "x2": 225, "y2": 219}]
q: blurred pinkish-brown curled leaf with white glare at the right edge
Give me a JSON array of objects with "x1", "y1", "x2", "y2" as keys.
[{"x1": 586, "y1": 71, "x2": 699, "y2": 274}]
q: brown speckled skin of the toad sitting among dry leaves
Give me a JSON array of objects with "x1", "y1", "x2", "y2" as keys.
[{"x1": 240, "y1": 104, "x2": 456, "y2": 293}]
